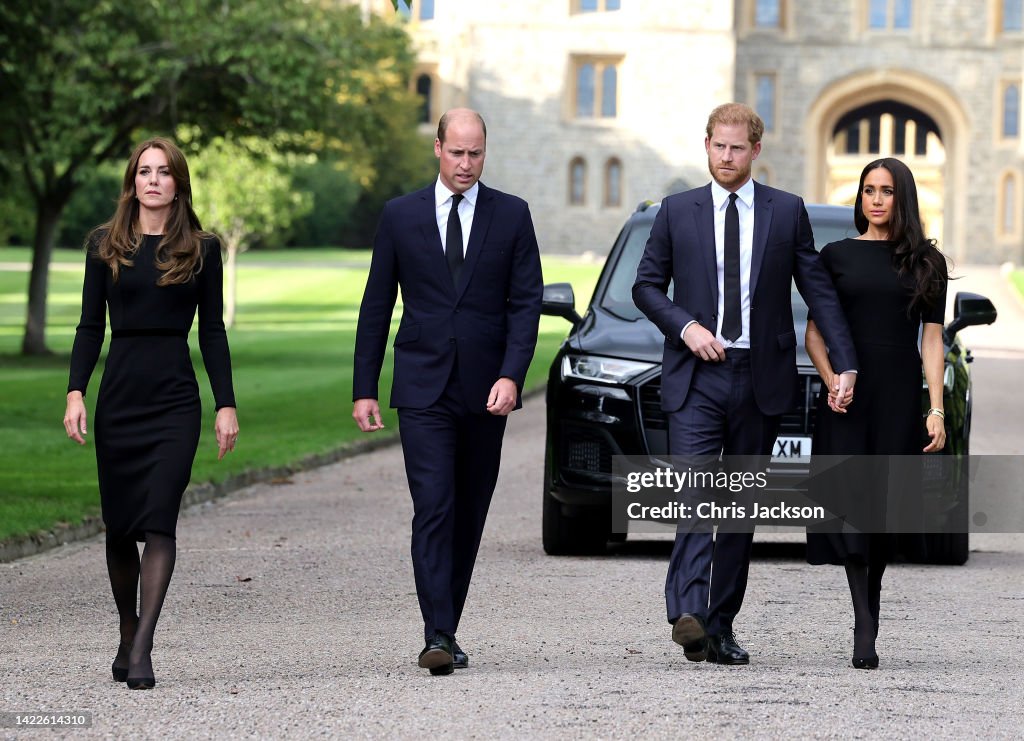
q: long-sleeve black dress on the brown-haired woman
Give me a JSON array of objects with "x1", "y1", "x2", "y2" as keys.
[{"x1": 68, "y1": 234, "x2": 234, "y2": 540}]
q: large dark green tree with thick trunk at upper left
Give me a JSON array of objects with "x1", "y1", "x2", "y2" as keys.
[{"x1": 0, "y1": 0, "x2": 416, "y2": 354}]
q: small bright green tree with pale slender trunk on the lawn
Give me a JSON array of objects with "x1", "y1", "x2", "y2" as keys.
[{"x1": 188, "y1": 137, "x2": 312, "y2": 328}]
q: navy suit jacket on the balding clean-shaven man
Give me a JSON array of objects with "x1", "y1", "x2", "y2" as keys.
[{"x1": 352, "y1": 183, "x2": 544, "y2": 412}]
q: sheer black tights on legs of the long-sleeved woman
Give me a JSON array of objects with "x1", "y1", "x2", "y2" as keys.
[{"x1": 106, "y1": 532, "x2": 175, "y2": 678}]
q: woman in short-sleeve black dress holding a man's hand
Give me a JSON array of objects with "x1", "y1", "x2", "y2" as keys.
[{"x1": 805, "y1": 158, "x2": 946, "y2": 668}]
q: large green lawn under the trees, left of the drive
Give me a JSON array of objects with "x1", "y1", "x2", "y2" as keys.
[{"x1": 0, "y1": 248, "x2": 600, "y2": 539}]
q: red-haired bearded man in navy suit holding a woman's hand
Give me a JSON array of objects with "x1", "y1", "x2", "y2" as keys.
[{"x1": 633, "y1": 103, "x2": 856, "y2": 664}]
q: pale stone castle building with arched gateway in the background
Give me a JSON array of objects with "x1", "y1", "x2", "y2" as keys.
[{"x1": 359, "y1": 0, "x2": 1024, "y2": 263}]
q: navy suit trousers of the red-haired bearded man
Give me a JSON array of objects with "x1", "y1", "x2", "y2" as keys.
[{"x1": 665, "y1": 349, "x2": 779, "y2": 636}]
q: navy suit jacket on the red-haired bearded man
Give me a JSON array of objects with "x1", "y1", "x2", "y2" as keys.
[{"x1": 633, "y1": 182, "x2": 857, "y2": 416}]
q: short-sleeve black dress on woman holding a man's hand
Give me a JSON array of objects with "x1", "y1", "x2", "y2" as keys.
[{"x1": 807, "y1": 238, "x2": 945, "y2": 564}]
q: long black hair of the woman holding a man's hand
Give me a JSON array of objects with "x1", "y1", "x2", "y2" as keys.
[{"x1": 853, "y1": 157, "x2": 948, "y2": 312}]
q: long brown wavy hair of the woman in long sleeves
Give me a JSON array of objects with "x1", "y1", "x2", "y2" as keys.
[{"x1": 88, "y1": 136, "x2": 212, "y2": 286}]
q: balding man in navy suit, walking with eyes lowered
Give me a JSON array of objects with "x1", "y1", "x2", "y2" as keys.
[{"x1": 352, "y1": 108, "x2": 544, "y2": 674}]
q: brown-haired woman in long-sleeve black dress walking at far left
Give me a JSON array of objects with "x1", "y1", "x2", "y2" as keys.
[{"x1": 63, "y1": 138, "x2": 239, "y2": 690}]
